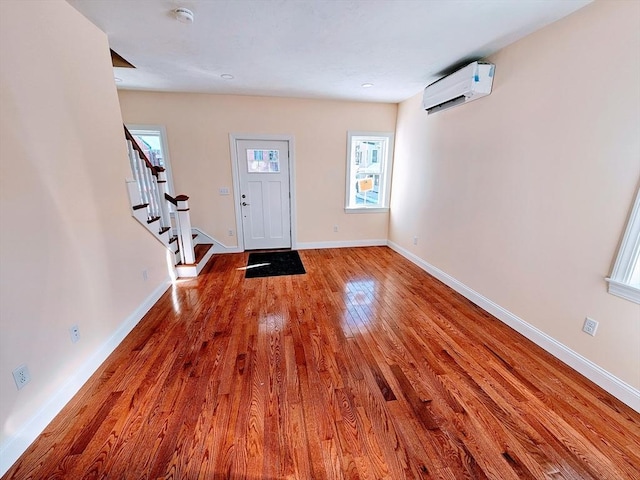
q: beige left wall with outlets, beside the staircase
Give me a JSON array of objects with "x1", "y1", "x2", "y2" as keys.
[{"x1": 0, "y1": 0, "x2": 167, "y2": 450}]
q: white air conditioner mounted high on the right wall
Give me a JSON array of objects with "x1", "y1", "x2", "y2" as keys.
[{"x1": 422, "y1": 62, "x2": 495, "y2": 114}]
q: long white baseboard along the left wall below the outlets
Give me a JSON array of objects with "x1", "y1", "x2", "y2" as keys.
[{"x1": 0, "y1": 277, "x2": 171, "y2": 476}]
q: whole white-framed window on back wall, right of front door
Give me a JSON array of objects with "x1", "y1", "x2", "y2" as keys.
[{"x1": 345, "y1": 132, "x2": 393, "y2": 212}]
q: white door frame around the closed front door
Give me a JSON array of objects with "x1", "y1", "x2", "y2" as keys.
[{"x1": 229, "y1": 133, "x2": 298, "y2": 252}]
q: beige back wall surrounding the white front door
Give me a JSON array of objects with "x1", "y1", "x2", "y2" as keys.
[{"x1": 119, "y1": 91, "x2": 397, "y2": 246}]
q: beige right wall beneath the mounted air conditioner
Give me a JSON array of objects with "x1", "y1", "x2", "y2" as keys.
[{"x1": 390, "y1": 1, "x2": 640, "y2": 388}]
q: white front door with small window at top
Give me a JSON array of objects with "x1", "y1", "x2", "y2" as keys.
[{"x1": 236, "y1": 140, "x2": 291, "y2": 250}]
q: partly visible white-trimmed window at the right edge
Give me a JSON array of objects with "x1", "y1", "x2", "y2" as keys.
[{"x1": 607, "y1": 191, "x2": 640, "y2": 303}]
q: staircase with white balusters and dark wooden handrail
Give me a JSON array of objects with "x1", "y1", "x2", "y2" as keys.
[{"x1": 124, "y1": 126, "x2": 213, "y2": 278}]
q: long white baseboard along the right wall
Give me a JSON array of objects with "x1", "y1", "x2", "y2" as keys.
[{"x1": 388, "y1": 241, "x2": 640, "y2": 412}]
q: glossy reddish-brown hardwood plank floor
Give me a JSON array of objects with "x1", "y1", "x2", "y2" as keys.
[{"x1": 4, "y1": 247, "x2": 640, "y2": 480}]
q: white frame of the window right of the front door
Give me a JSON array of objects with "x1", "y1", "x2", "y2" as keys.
[{"x1": 344, "y1": 131, "x2": 394, "y2": 213}]
